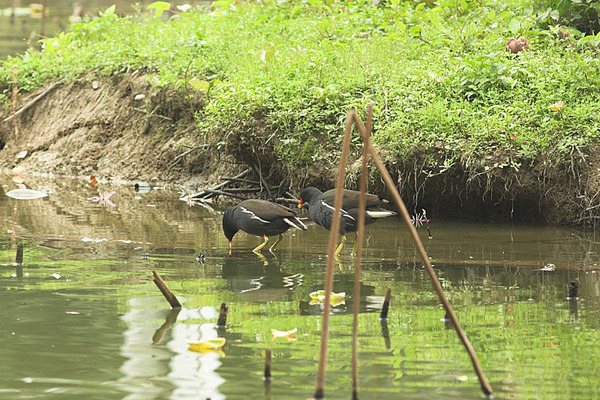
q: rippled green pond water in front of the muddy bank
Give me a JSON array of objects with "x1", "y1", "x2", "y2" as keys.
[{"x1": 0, "y1": 177, "x2": 600, "y2": 400}]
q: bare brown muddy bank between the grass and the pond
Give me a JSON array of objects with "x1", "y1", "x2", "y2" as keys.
[{"x1": 0, "y1": 73, "x2": 600, "y2": 225}]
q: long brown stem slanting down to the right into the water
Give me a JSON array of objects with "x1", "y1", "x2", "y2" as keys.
[{"x1": 348, "y1": 111, "x2": 494, "y2": 397}]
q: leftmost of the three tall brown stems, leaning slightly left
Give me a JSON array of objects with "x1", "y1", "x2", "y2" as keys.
[{"x1": 314, "y1": 110, "x2": 353, "y2": 399}]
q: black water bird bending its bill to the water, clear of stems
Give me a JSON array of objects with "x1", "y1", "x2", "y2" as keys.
[{"x1": 223, "y1": 199, "x2": 306, "y2": 254}]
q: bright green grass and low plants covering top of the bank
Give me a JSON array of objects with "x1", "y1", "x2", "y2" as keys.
[{"x1": 0, "y1": 0, "x2": 600, "y2": 191}]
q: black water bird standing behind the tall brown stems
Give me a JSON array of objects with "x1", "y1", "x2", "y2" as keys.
[{"x1": 298, "y1": 186, "x2": 396, "y2": 256}]
